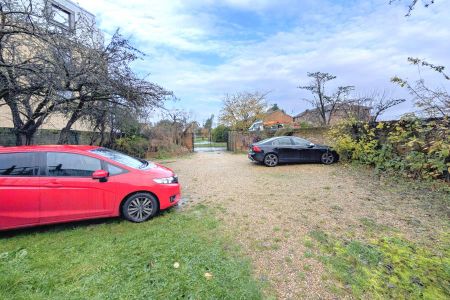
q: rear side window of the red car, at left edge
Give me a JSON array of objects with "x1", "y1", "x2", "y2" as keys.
[{"x1": 0, "y1": 152, "x2": 39, "y2": 176}]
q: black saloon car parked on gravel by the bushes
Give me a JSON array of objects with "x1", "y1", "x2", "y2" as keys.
[{"x1": 248, "y1": 136, "x2": 339, "y2": 167}]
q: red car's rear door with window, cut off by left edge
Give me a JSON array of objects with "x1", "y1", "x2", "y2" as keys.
[{"x1": 0, "y1": 152, "x2": 40, "y2": 229}]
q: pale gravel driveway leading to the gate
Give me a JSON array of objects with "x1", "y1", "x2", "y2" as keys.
[{"x1": 165, "y1": 153, "x2": 448, "y2": 299}]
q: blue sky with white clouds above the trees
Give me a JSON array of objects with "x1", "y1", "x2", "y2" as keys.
[{"x1": 78, "y1": 0, "x2": 450, "y2": 122}]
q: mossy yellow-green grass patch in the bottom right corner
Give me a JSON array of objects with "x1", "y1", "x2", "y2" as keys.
[{"x1": 310, "y1": 231, "x2": 450, "y2": 299}]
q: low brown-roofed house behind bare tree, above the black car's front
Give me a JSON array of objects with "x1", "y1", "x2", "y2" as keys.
[{"x1": 294, "y1": 104, "x2": 371, "y2": 126}]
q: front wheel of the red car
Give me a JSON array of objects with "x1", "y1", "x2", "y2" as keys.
[{"x1": 122, "y1": 193, "x2": 159, "y2": 223}]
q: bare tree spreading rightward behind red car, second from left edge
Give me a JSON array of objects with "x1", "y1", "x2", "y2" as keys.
[{"x1": 59, "y1": 32, "x2": 173, "y2": 144}]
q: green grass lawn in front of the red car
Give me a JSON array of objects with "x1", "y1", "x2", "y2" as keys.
[{"x1": 0, "y1": 205, "x2": 261, "y2": 299}]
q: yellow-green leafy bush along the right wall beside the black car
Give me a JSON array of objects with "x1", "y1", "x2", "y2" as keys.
[{"x1": 330, "y1": 117, "x2": 450, "y2": 180}]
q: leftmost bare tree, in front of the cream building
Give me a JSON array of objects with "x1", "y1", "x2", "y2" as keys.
[{"x1": 0, "y1": 0, "x2": 106, "y2": 145}]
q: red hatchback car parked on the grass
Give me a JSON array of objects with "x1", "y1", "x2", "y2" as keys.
[{"x1": 0, "y1": 146, "x2": 180, "y2": 230}]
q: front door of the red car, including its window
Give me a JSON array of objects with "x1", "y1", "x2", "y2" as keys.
[{"x1": 41, "y1": 152, "x2": 114, "y2": 223}]
